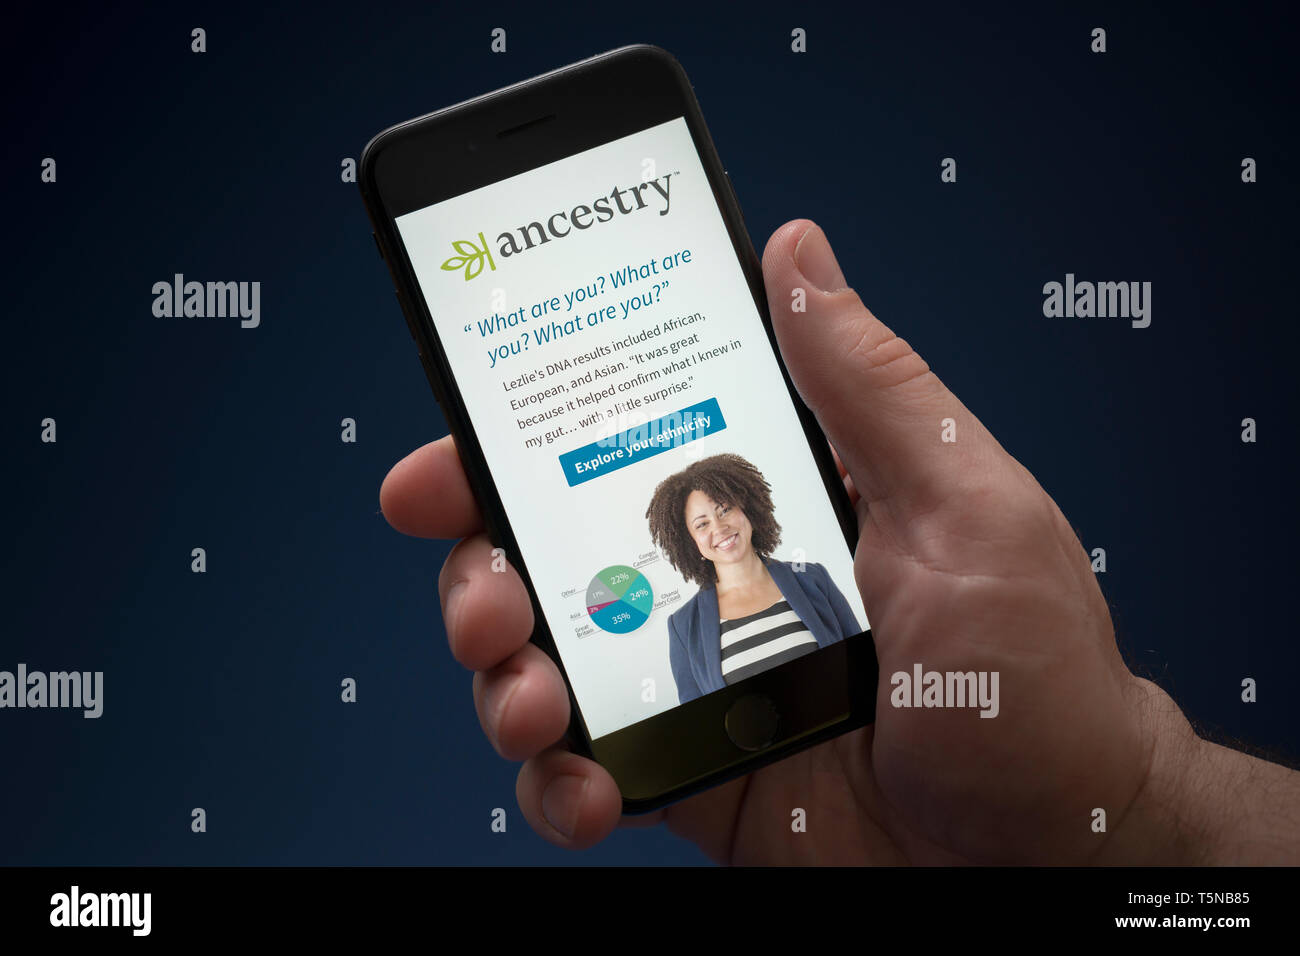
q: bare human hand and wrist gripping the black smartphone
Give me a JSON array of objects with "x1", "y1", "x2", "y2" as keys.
[{"x1": 381, "y1": 220, "x2": 1300, "y2": 864}]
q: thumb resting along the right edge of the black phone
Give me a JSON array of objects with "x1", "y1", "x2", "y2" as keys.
[{"x1": 763, "y1": 220, "x2": 1006, "y2": 509}]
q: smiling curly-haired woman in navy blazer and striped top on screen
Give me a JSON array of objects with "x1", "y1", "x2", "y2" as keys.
[{"x1": 646, "y1": 454, "x2": 861, "y2": 704}]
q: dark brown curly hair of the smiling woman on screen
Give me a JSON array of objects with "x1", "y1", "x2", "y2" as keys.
[{"x1": 646, "y1": 454, "x2": 781, "y2": 588}]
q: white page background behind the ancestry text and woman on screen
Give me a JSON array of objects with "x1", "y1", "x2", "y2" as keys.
[{"x1": 397, "y1": 117, "x2": 867, "y2": 737}]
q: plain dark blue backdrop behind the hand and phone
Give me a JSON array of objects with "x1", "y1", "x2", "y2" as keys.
[{"x1": 0, "y1": 3, "x2": 1300, "y2": 864}]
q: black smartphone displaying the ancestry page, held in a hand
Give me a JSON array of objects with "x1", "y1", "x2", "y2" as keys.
[{"x1": 359, "y1": 46, "x2": 879, "y2": 813}]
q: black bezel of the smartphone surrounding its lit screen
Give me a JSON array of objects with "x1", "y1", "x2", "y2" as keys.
[{"x1": 358, "y1": 44, "x2": 879, "y2": 813}]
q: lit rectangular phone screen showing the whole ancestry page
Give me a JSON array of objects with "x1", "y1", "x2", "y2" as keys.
[{"x1": 397, "y1": 117, "x2": 868, "y2": 739}]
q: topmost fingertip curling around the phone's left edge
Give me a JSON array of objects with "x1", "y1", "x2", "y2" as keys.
[{"x1": 380, "y1": 434, "x2": 484, "y2": 538}]
